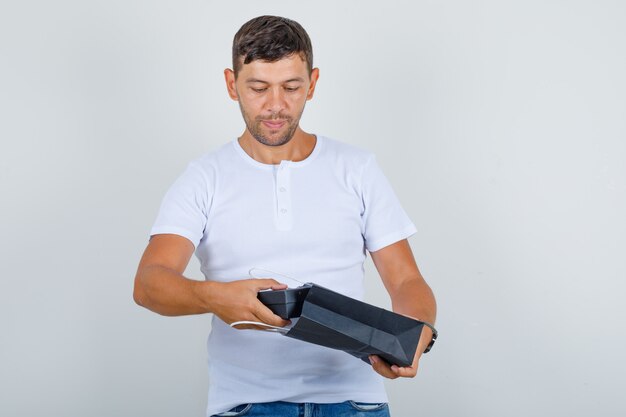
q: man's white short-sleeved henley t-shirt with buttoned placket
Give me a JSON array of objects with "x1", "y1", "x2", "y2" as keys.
[{"x1": 151, "y1": 136, "x2": 416, "y2": 415}]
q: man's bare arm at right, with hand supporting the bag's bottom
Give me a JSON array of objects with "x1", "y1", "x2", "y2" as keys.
[{"x1": 370, "y1": 239, "x2": 437, "y2": 378}]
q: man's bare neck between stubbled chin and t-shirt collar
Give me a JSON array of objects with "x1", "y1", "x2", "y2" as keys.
[{"x1": 239, "y1": 128, "x2": 317, "y2": 165}]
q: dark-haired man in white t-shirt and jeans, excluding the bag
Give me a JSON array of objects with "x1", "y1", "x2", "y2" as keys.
[{"x1": 134, "y1": 16, "x2": 435, "y2": 416}]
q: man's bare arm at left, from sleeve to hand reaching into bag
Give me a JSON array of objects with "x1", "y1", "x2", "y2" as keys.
[{"x1": 133, "y1": 234, "x2": 289, "y2": 328}]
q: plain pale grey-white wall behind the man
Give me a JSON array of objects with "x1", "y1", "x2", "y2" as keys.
[{"x1": 0, "y1": 0, "x2": 626, "y2": 417}]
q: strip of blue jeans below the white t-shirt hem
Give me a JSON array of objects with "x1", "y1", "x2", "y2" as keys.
[{"x1": 212, "y1": 401, "x2": 389, "y2": 417}]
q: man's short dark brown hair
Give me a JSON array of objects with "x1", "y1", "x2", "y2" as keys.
[{"x1": 233, "y1": 16, "x2": 313, "y2": 77}]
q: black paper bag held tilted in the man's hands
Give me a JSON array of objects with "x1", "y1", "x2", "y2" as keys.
[{"x1": 259, "y1": 284, "x2": 437, "y2": 366}]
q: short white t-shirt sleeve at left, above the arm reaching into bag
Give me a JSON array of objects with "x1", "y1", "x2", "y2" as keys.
[{"x1": 150, "y1": 162, "x2": 212, "y2": 247}]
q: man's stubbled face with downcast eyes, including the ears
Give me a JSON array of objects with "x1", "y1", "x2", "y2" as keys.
[{"x1": 225, "y1": 54, "x2": 318, "y2": 146}]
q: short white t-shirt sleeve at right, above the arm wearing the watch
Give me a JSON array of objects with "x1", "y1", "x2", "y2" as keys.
[{"x1": 361, "y1": 155, "x2": 417, "y2": 252}]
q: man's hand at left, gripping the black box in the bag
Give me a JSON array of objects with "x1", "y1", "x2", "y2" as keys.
[{"x1": 207, "y1": 279, "x2": 291, "y2": 330}]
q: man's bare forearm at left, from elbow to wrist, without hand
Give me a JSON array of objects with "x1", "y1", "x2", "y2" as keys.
[{"x1": 133, "y1": 265, "x2": 215, "y2": 316}]
